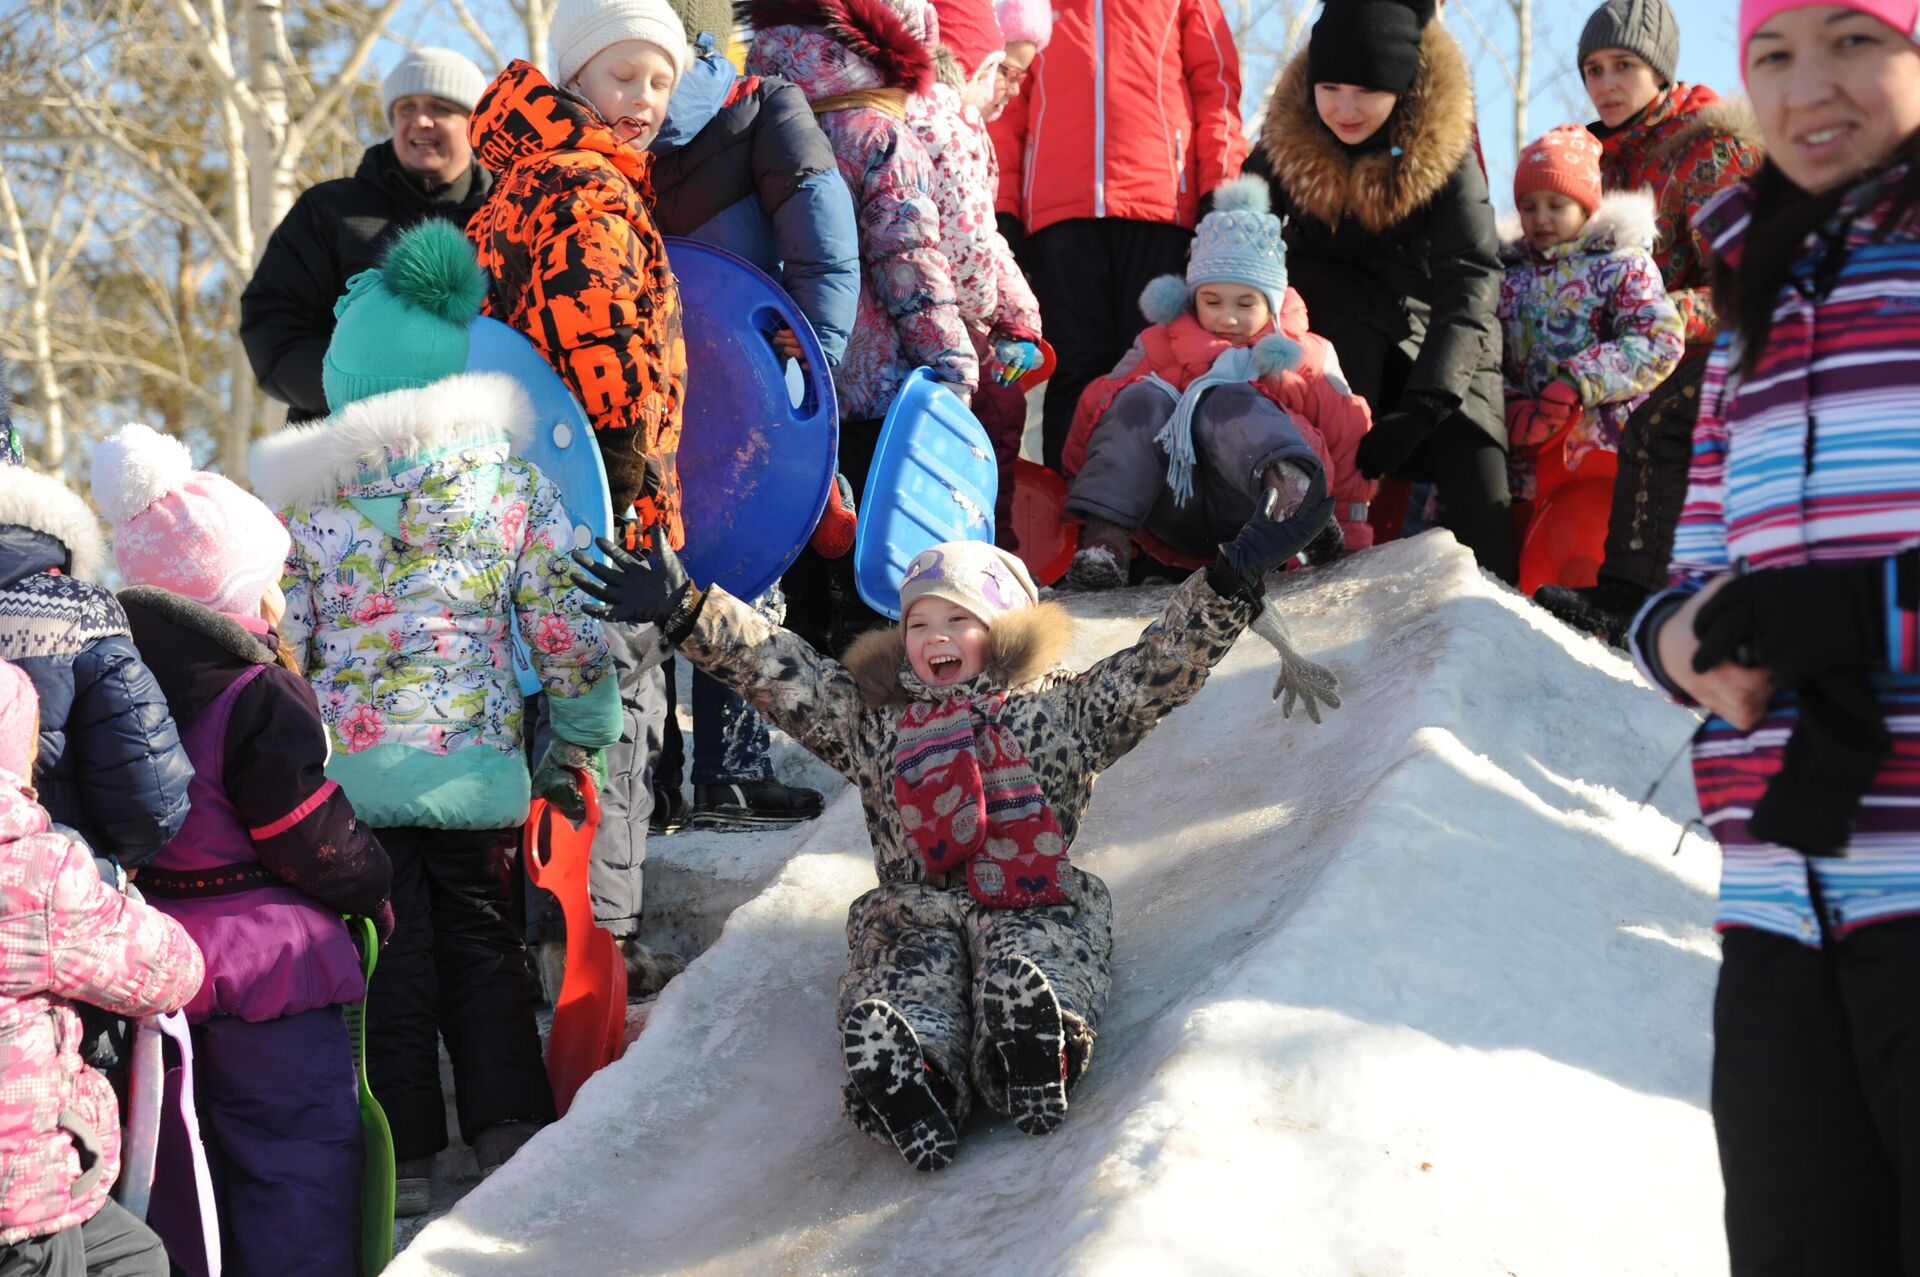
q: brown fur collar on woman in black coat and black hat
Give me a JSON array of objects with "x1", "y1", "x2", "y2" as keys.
[{"x1": 1260, "y1": 23, "x2": 1475, "y2": 234}]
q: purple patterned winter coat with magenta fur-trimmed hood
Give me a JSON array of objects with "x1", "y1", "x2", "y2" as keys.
[{"x1": 747, "y1": 0, "x2": 979, "y2": 421}]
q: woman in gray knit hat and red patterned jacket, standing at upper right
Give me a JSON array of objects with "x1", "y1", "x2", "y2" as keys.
[{"x1": 1534, "y1": 0, "x2": 1761, "y2": 645}]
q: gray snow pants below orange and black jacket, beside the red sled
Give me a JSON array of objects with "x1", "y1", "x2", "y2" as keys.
[{"x1": 526, "y1": 624, "x2": 666, "y2": 945}]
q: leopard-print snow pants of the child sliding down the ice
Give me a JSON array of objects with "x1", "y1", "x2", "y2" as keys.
[{"x1": 839, "y1": 866, "x2": 1114, "y2": 1141}]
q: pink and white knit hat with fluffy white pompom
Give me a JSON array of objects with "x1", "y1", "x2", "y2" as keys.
[{"x1": 94, "y1": 424, "x2": 294, "y2": 618}]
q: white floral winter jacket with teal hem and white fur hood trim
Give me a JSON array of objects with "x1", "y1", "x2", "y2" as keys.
[{"x1": 250, "y1": 373, "x2": 620, "y2": 830}]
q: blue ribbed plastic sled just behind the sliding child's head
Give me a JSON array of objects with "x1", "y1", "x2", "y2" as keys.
[{"x1": 852, "y1": 369, "x2": 1000, "y2": 620}]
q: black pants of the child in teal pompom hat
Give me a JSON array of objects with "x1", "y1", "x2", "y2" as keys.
[{"x1": 367, "y1": 828, "x2": 553, "y2": 1162}]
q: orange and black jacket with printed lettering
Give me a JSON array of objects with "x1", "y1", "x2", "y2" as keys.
[{"x1": 467, "y1": 60, "x2": 687, "y2": 547}]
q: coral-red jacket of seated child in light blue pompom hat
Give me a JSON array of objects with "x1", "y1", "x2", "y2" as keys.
[{"x1": 1060, "y1": 288, "x2": 1373, "y2": 566}]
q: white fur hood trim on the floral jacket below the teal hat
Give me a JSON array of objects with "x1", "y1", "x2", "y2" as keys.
[{"x1": 248, "y1": 373, "x2": 534, "y2": 511}]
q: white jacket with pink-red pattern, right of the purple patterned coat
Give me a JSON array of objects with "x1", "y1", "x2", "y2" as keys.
[{"x1": 906, "y1": 84, "x2": 1041, "y2": 342}]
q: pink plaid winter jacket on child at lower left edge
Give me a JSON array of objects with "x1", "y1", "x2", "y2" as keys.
[{"x1": 0, "y1": 772, "x2": 205, "y2": 1246}]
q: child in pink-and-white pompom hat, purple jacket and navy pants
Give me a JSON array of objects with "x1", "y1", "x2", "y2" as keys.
[{"x1": 92, "y1": 420, "x2": 393, "y2": 1277}]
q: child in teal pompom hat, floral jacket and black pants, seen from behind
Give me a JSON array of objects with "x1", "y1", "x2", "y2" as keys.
[{"x1": 248, "y1": 223, "x2": 620, "y2": 1214}]
